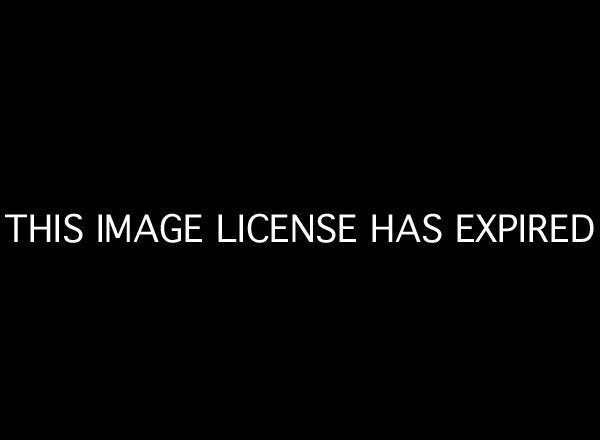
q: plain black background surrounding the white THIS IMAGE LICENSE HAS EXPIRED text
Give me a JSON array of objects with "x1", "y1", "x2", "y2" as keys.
[{"x1": 1, "y1": 5, "x2": 598, "y2": 433}]
